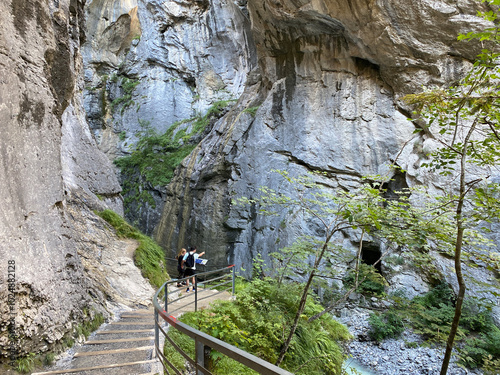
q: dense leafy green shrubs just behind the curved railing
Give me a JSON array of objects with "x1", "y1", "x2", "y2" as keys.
[{"x1": 164, "y1": 278, "x2": 351, "y2": 375}]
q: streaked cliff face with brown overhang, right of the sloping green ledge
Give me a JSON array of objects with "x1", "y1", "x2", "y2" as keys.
[{"x1": 156, "y1": 0, "x2": 496, "y2": 276}]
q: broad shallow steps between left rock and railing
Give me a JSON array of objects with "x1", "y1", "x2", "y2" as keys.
[{"x1": 32, "y1": 309, "x2": 161, "y2": 375}]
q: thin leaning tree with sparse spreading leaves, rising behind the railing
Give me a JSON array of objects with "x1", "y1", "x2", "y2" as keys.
[{"x1": 234, "y1": 171, "x2": 442, "y2": 366}]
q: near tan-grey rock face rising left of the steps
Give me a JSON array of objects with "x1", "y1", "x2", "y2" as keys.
[{"x1": 0, "y1": 0, "x2": 148, "y2": 358}]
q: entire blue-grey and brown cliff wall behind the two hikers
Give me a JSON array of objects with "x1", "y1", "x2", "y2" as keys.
[{"x1": 84, "y1": 0, "x2": 496, "y2": 306}]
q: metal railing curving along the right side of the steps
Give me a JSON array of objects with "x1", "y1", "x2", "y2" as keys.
[{"x1": 153, "y1": 266, "x2": 292, "y2": 375}]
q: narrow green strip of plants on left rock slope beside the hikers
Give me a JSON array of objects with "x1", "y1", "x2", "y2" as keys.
[{"x1": 97, "y1": 210, "x2": 169, "y2": 288}]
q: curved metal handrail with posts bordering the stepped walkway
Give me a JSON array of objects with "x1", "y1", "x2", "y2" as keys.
[{"x1": 153, "y1": 265, "x2": 293, "y2": 375}]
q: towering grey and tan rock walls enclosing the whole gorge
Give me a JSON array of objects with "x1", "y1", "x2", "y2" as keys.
[{"x1": 0, "y1": 0, "x2": 500, "y2": 374}]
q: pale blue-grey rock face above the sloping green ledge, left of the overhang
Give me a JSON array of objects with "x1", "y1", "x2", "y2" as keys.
[{"x1": 83, "y1": 0, "x2": 256, "y2": 233}]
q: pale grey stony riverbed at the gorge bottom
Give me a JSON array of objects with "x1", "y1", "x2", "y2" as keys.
[{"x1": 338, "y1": 308, "x2": 482, "y2": 375}]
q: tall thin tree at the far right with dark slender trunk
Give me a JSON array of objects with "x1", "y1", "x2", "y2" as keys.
[{"x1": 405, "y1": 0, "x2": 500, "y2": 375}]
